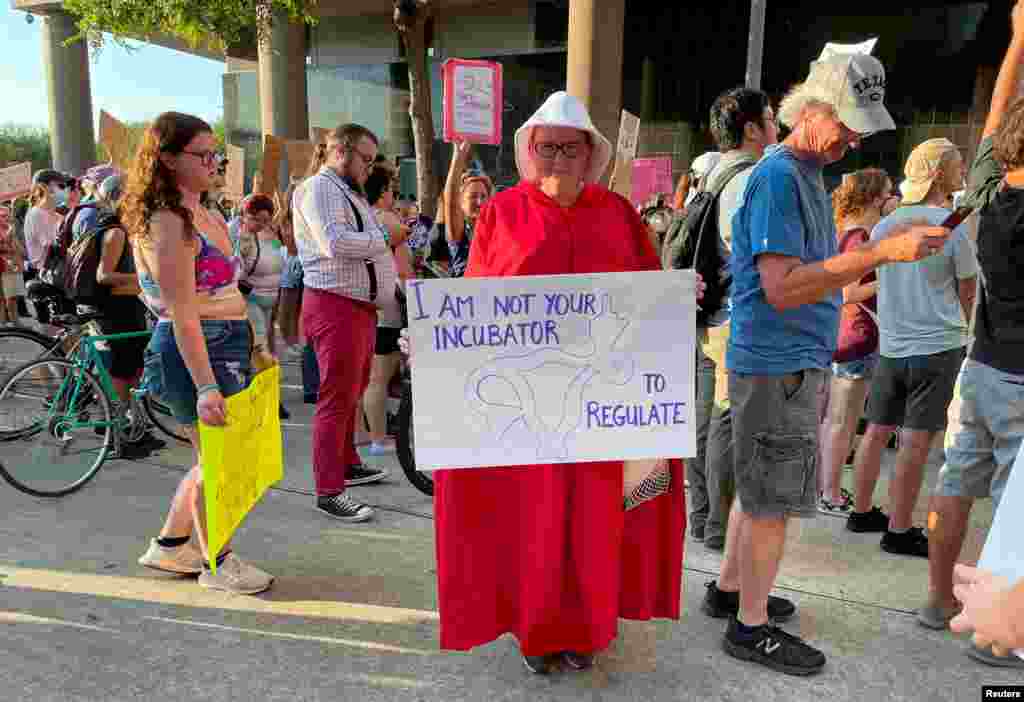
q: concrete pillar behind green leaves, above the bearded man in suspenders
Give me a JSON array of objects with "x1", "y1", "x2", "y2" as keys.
[{"x1": 259, "y1": 14, "x2": 309, "y2": 139}]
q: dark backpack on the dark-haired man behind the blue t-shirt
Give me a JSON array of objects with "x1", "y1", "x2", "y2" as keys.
[{"x1": 662, "y1": 161, "x2": 754, "y2": 326}]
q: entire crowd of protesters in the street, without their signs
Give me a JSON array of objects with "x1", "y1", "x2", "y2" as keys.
[{"x1": 0, "y1": 4, "x2": 1024, "y2": 675}]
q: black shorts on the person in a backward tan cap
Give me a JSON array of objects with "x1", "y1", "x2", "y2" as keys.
[{"x1": 867, "y1": 349, "x2": 965, "y2": 432}]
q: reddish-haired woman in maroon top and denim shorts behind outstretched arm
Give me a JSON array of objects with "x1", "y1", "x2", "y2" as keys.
[{"x1": 818, "y1": 168, "x2": 899, "y2": 517}]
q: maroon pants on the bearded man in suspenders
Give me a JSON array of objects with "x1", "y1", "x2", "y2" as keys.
[{"x1": 302, "y1": 288, "x2": 377, "y2": 495}]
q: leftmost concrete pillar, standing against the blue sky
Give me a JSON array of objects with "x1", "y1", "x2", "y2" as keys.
[{"x1": 42, "y1": 11, "x2": 96, "y2": 175}]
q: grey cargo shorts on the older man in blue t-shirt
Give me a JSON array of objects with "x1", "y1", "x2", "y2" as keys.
[{"x1": 729, "y1": 369, "x2": 827, "y2": 518}]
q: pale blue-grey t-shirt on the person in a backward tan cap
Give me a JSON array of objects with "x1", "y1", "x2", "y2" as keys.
[{"x1": 871, "y1": 205, "x2": 978, "y2": 358}]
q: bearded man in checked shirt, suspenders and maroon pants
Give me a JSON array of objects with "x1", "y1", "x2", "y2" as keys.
[{"x1": 293, "y1": 124, "x2": 397, "y2": 522}]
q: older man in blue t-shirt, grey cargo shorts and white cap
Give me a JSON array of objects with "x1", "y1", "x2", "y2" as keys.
[{"x1": 702, "y1": 54, "x2": 949, "y2": 675}]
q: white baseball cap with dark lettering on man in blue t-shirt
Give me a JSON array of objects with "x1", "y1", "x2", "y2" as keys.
[{"x1": 807, "y1": 53, "x2": 896, "y2": 135}]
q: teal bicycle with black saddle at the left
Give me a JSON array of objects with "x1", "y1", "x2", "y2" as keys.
[{"x1": 0, "y1": 314, "x2": 186, "y2": 497}]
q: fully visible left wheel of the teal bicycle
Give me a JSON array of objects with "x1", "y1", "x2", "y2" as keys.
[{"x1": 0, "y1": 359, "x2": 116, "y2": 497}]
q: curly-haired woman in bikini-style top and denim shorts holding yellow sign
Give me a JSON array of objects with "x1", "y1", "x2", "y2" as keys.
[{"x1": 121, "y1": 113, "x2": 273, "y2": 595}]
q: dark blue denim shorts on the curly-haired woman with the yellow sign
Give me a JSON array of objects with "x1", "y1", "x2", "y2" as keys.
[{"x1": 142, "y1": 319, "x2": 252, "y2": 425}]
